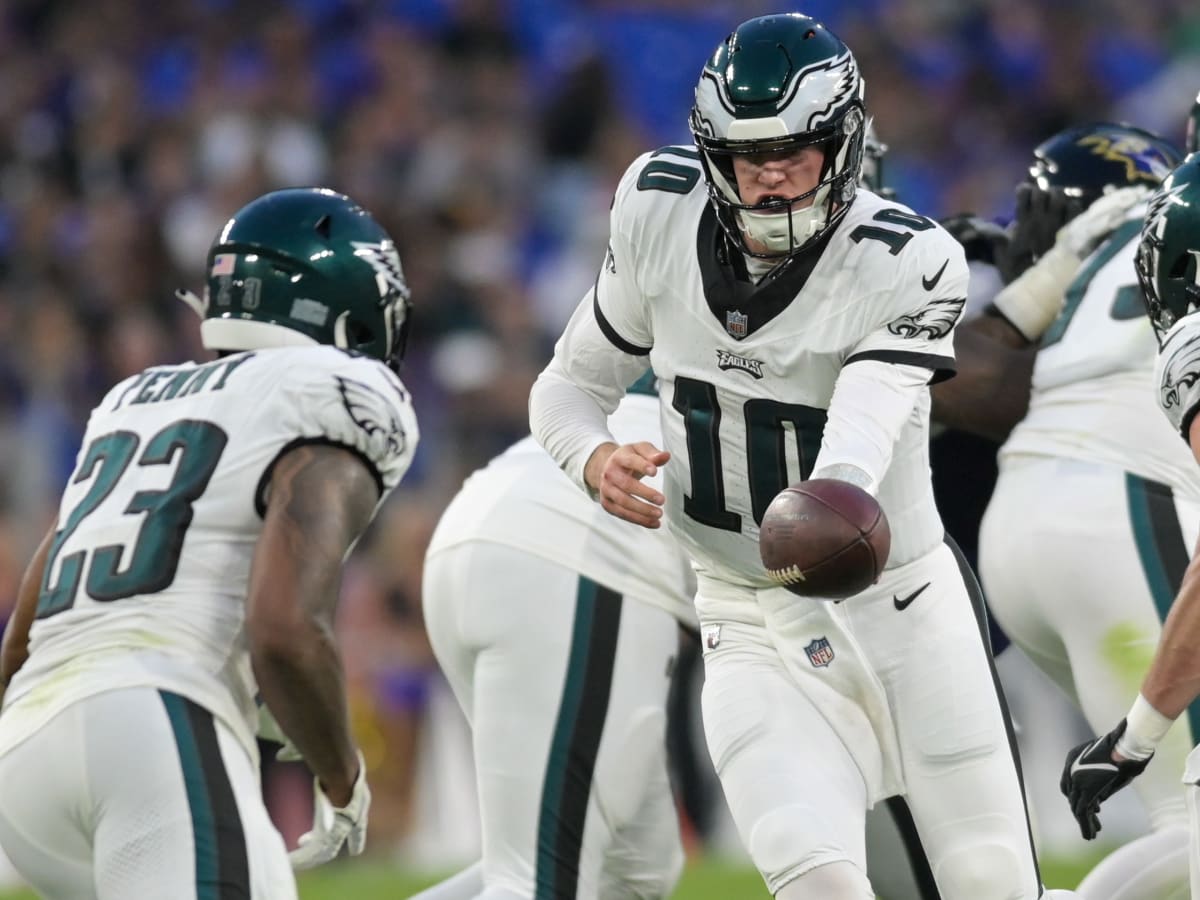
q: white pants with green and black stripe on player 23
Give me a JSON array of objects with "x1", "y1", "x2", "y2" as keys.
[{"x1": 4, "y1": 688, "x2": 296, "y2": 900}]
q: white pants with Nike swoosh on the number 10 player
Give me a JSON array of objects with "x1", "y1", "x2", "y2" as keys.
[{"x1": 697, "y1": 545, "x2": 1042, "y2": 900}]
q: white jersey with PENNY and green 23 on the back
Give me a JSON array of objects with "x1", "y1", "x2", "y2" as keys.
[{"x1": 0, "y1": 346, "x2": 418, "y2": 754}]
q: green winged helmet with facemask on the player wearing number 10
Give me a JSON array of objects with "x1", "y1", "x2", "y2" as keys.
[{"x1": 689, "y1": 13, "x2": 866, "y2": 258}]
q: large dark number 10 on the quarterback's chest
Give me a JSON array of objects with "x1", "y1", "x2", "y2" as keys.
[{"x1": 671, "y1": 378, "x2": 826, "y2": 532}]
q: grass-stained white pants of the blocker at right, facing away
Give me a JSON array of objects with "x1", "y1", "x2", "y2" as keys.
[{"x1": 980, "y1": 460, "x2": 1200, "y2": 827}]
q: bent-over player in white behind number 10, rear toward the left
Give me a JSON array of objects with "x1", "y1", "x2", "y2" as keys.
[{"x1": 418, "y1": 378, "x2": 696, "y2": 900}]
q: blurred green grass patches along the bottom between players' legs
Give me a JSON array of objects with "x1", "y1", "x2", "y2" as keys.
[{"x1": 0, "y1": 853, "x2": 1103, "y2": 900}]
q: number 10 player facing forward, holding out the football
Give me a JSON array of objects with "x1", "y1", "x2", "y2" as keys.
[{"x1": 530, "y1": 13, "x2": 1075, "y2": 900}]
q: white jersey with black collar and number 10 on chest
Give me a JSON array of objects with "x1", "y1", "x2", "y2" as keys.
[{"x1": 534, "y1": 148, "x2": 967, "y2": 587}]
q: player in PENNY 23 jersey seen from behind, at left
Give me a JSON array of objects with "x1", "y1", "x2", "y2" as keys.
[{"x1": 0, "y1": 188, "x2": 418, "y2": 900}]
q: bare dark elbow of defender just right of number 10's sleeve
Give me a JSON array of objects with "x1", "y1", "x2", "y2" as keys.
[{"x1": 930, "y1": 314, "x2": 1036, "y2": 442}]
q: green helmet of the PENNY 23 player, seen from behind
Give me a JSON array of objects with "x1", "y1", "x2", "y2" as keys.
[{"x1": 179, "y1": 187, "x2": 410, "y2": 371}]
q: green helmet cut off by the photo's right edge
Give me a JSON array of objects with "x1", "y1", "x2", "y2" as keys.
[{"x1": 1136, "y1": 154, "x2": 1200, "y2": 338}]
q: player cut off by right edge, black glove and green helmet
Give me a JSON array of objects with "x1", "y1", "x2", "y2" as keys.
[{"x1": 1062, "y1": 151, "x2": 1200, "y2": 896}]
